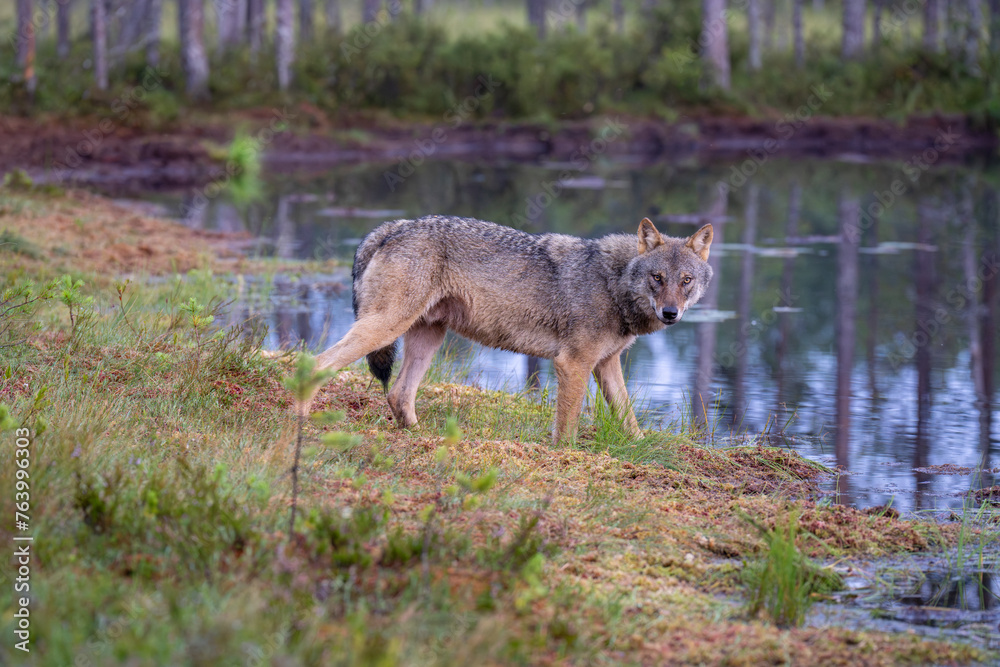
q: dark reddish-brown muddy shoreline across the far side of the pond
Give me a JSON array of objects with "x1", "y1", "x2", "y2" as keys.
[{"x1": 0, "y1": 107, "x2": 1000, "y2": 191}]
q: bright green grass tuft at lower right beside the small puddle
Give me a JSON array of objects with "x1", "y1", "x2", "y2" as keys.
[{"x1": 743, "y1": 512, "x2": 843, "y2": 627}]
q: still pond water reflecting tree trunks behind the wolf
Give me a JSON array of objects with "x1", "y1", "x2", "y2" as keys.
[{"x1": 139, "y1": 158, "x2": 1000, "y2": 517}]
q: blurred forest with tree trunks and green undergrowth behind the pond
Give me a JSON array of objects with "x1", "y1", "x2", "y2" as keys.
[{"x1": 0, "y1": 0, "x2": 1000, "y2": 124}]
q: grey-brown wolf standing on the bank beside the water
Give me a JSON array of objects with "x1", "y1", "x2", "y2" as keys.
[{"x1": 319, "y1": 216, "x2": 712, "y2": 442}]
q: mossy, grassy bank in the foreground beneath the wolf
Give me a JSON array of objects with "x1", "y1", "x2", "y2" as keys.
[{"x1": 0, "y1": 188, "x2": 992, "y2": 665}]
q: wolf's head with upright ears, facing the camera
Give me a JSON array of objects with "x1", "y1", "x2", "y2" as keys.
[{"x1": 628, "y1": 218, "x2": 712, "y2": 326}]
